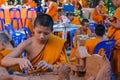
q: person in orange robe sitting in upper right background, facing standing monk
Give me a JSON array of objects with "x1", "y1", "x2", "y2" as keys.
[{"x1": 91, "y1": 0, "x2": 108, "y2": 24}]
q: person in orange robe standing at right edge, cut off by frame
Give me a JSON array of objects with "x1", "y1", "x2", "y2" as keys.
[{"x1": 106, "y1": 0, "x2": 120, "y2": 80}]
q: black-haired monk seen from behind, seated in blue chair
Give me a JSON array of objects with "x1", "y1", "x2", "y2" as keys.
[{"x1": 85, "y1": 24, "x2": 105, "y2": 55}]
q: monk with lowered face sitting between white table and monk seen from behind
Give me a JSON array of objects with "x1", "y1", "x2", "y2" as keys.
[{"x1": 70, "y1": 19, "x2": 92, "y2": 60}]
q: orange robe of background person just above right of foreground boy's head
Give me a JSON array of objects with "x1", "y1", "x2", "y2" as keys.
[{"x1": 46, "y1": 1, "x2": 58, "y2": 23}]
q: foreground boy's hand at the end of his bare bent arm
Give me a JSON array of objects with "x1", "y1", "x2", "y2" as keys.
[{"x1": 18, "y1": 58, "x2": 34, "y2": 70}]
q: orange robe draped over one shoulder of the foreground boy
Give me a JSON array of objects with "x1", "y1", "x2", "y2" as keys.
[{"x1": 31, "y1": 35, "x2": 68, "y2": 72}]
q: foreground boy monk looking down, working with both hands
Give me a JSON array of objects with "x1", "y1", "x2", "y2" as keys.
[{"x1": 1, "y1": 14, "x2": 68, "y2": 72}]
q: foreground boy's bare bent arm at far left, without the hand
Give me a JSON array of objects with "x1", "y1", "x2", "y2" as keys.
[{"x1": 1, "y1": 42, "x2": 26, "y2": 66}]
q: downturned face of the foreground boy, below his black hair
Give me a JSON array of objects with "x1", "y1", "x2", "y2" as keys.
[{"x1": 34, "y1": 25, "x2": 52, "y2": 43}]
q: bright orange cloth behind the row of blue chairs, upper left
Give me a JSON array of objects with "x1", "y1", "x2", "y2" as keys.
[{"x1": 0, "y1": 6, "x2": 37, "y2": 29}]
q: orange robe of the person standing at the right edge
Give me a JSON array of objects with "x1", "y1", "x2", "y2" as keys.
[{"x1": 108, "y1": 7, "x2": 120, "y2": 74}]
